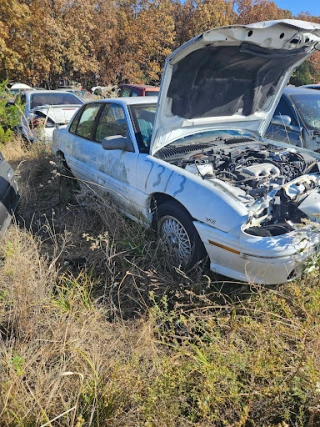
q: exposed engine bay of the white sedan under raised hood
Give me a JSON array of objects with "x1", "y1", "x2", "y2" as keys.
[{"x1": 161, "y1": 140, "x2": 320, "y2": 237}]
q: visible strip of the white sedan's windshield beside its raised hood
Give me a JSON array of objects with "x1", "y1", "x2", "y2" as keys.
[{"x1": 131, "y1": 104, "x2": 157, "y2": 148}]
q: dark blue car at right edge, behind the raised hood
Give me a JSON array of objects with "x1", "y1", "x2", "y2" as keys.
[{"x1": 265, "y1": 85, "x2": 320, "y2": 151}]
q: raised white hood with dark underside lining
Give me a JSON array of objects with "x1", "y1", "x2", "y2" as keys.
[{"x1": 150, "y1": 19, "x2": 320, "y2": 154}]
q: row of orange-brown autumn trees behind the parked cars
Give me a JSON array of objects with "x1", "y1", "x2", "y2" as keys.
[{"x1": 0, "y1": 0, "x2": 320, "y2": 88}]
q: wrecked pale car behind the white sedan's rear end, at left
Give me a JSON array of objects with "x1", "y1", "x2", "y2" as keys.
[{"x1": 8, "y1": 90, "x2": 84, "y2": 142}]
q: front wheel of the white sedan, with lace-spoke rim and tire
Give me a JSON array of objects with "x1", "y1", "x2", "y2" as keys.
[{"x1": 157, "y1": 202, "x2": 207, "y2": 268}]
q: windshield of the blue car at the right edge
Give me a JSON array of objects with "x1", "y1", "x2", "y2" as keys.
[{"x1": 290, "y1": 92, "x2": 320, "y2": 130}]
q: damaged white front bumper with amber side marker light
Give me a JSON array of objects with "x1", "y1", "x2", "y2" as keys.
[{"x1": 194, "y1": 222, "x2": 320, "y2": 285}]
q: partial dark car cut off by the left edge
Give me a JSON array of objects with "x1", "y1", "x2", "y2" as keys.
[{"x1": 0, "y1": 152, "x2": 20, "y2": 237}]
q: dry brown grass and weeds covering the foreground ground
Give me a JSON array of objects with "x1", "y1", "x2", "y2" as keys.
[{"x1": 0, "y1": 141, "x2": 320, "y2": 427}]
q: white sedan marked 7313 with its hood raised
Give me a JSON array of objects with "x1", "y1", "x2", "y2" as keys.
[{"x1": 52, "y1": 20, "x2": 320, "y2": 284}]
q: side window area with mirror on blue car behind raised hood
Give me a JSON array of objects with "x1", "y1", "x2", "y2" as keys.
[{"x1": 265, "y1": 97, "x2": 303, "y2": 147}]
